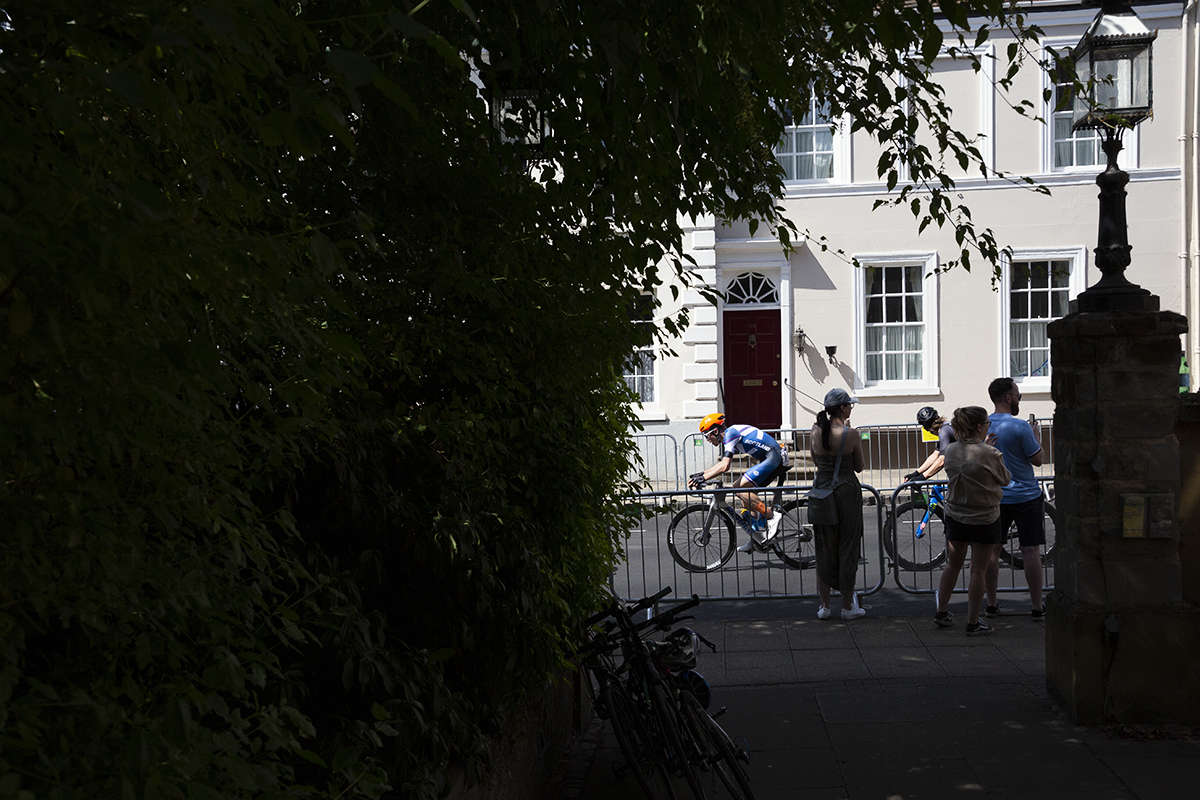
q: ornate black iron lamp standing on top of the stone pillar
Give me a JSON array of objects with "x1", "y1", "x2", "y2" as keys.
[{"x1": 1072, "y1": 0, "x2": 1158, "y2": 311}]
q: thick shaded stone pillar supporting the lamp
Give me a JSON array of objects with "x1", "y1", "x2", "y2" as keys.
[{"x1": 1046, "y1": 311, "x2": 1200, "y2": 724}]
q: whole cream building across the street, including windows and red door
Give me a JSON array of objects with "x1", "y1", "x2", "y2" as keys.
[{"x1": 636, "y1": 0, "x2": 1200, "y2": 439}]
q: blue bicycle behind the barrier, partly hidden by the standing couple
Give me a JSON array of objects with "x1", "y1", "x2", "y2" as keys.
[{"x1": 883, "y1": 482, "x2": 1058, "y2": 572}]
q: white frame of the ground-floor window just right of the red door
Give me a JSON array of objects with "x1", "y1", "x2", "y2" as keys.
[{"x1": 854, "y1": 253, "x2": 941, "y2": 397}]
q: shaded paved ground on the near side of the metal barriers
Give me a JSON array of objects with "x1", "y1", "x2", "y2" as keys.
[{"x1": 554, "y1": 591, "x2": 1200, "y2": 800}]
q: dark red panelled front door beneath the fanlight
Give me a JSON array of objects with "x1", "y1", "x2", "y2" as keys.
[{"x1": 722, "y1": 308, "x2": 784, "y2": 429}]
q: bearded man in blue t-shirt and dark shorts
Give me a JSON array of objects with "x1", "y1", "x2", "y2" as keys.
[{"x1": 984, "y1": 378, "x2": 1046, "y2": 619}]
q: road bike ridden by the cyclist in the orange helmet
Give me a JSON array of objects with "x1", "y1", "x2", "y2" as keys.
[{"x1": 667, "y1": 481, "x2": 817, "y2": 572}]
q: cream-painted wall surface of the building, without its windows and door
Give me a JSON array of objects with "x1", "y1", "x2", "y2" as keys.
[{"x1": 643, "y1": 0, "x2": 1200, "y2": 437}]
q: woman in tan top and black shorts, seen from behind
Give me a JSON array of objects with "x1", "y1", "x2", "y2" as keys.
[{"x1": 934, "y1": 405, "x2": 1013, "y2": 636}]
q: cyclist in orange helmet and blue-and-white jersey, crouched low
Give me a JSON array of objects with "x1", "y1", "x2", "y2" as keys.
[{"x1": 688, "y1": 414, "x2": 788, "y2": 553}]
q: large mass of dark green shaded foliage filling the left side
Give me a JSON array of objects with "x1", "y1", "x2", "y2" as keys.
[{"x1": 0, "y1": 0, "x2": 1046, "y2": 800}]
